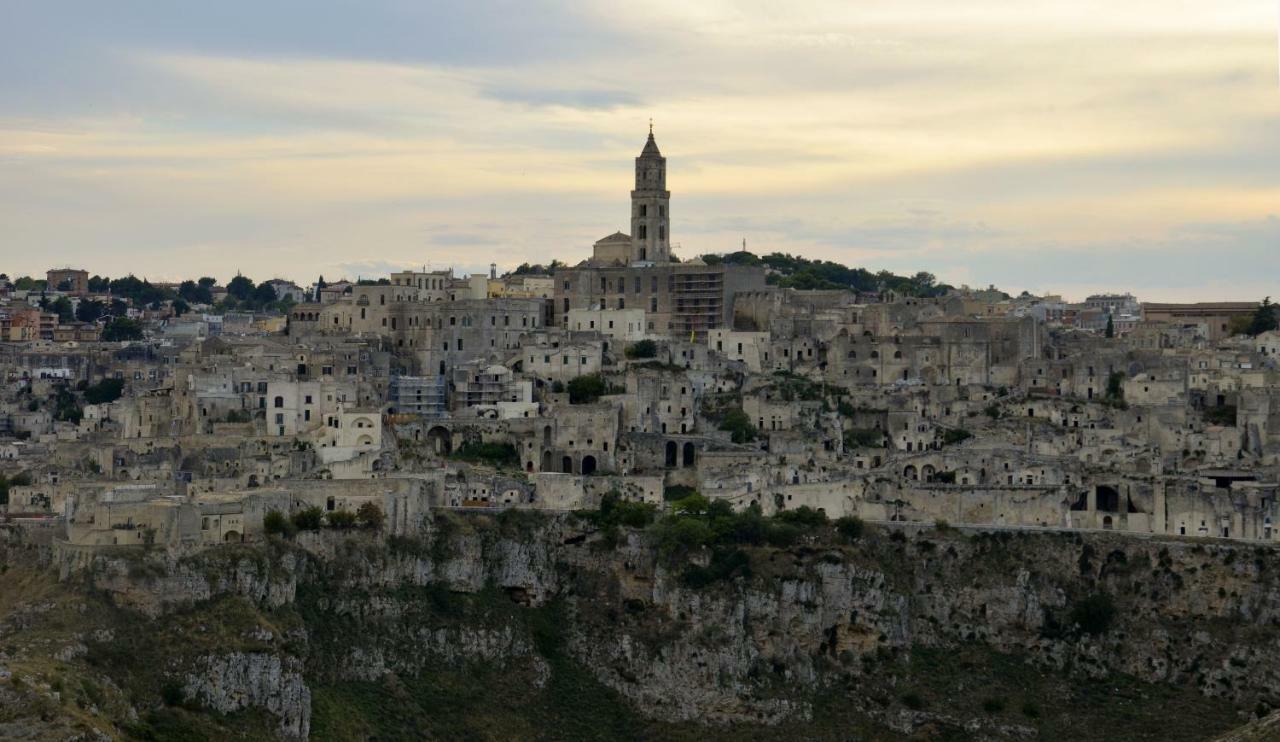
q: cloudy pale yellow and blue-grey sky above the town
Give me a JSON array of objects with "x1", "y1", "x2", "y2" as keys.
[{"x1": 0, "y1": 0, "x2": 1280, "y2": 301}]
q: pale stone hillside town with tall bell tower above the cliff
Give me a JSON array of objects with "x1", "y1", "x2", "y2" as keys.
[{"x1": 0, "y1": 134, "x2": 1280, "y2": 562}]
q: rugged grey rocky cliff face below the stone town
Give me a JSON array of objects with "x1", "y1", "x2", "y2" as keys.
[{"x1": 10, "y1": 516, "x2": 1280, "y2": 738}]
